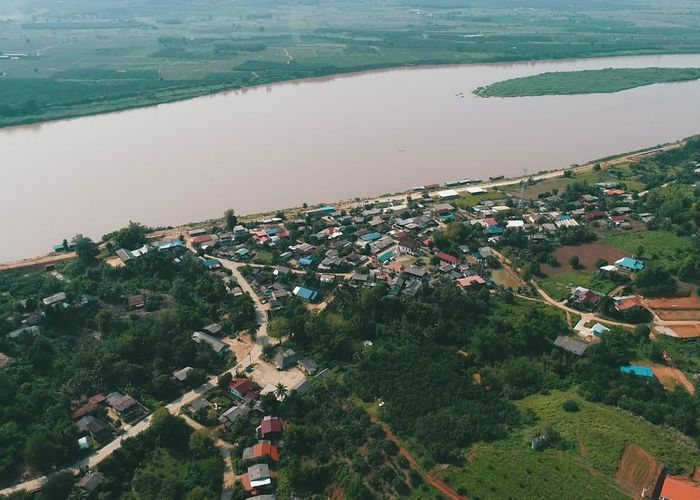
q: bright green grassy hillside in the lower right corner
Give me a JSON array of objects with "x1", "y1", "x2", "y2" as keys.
[{"x1": 440, "y1": 391, "x2": 700, "y2": 499}]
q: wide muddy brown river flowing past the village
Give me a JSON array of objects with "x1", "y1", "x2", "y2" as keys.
[{"x1": 0, "y1": 55, "x2": 700, "y2": 261}]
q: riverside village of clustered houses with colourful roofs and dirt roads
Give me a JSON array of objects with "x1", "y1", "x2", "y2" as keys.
[{"x1": 0, "y1": 142, "x2": 700, "y2": 499}]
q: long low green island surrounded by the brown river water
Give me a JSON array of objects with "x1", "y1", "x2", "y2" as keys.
[{"x1": 474, "y1": 68, "x2": 700, "y2": 97}]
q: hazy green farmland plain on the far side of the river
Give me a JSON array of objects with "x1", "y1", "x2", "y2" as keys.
[{"x1": 5, "y1": 0, "x2": 700, "y2": 126}]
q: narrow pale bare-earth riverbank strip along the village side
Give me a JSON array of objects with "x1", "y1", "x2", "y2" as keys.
[{"x1": 0, "y1": 139, "x2": 687, "y2": 272}]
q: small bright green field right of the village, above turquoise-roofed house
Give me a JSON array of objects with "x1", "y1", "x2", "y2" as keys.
[{"x1": 602, "y1": 231, "x2": 692, "y2": 265}]
